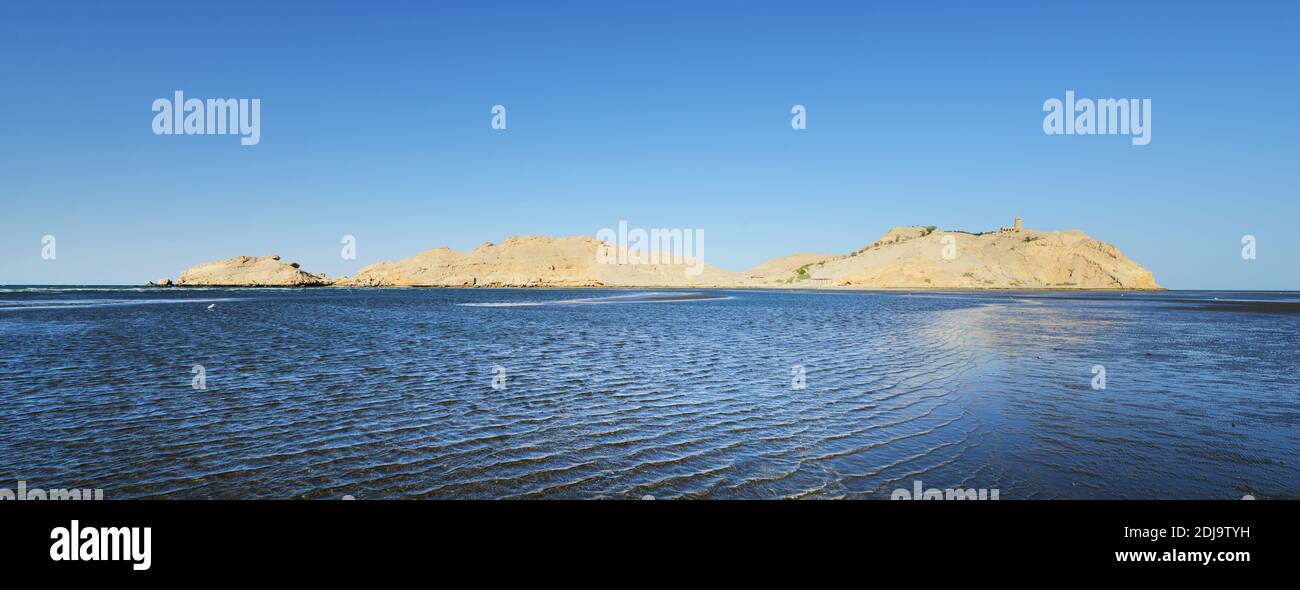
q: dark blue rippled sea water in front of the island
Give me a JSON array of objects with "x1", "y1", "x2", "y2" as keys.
[{"x1": 0, "y1": 287, "x2": 1300, "y2": 499}]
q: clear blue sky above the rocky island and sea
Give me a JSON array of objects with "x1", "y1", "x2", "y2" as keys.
[{"x1": 0, "y1": 1, "x2": 1300, "y2": 290}]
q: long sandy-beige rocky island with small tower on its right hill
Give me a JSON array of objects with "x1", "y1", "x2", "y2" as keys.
[{"x1": 151, "y1": 218, "x2": 1161, "y2": 290}]
